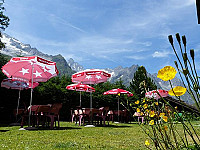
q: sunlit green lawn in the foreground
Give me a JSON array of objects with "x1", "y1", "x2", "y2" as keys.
[{"x1": 0, "y1": 122, "x2": 200, "y2": 150}]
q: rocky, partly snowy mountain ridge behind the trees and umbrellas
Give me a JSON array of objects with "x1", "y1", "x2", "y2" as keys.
[{"x1": 1, "y1": 33, "x2": 192, "y2": 104}]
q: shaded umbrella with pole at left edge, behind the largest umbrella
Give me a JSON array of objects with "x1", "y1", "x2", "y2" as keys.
[{"x1": 1, "y1": 78, "x2": 39, "y2": 119}]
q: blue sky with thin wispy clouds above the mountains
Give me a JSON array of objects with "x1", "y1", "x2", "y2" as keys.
[{"x1": 4, "y1": 0, "x2": 200, "y2": 73}]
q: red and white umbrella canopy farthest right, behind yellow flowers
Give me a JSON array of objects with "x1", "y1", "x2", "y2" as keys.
[{"x1": 145, "y1": 90, "x2": 168, "y2": 99}]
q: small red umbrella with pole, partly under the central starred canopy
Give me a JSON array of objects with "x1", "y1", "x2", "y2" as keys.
[{"x1": 66, "y1": 84, "x2": 95, "y2": 106}]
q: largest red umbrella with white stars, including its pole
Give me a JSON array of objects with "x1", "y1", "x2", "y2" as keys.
[{"x1": 2, "y1": 56, "x2": 58, "y2": 124}]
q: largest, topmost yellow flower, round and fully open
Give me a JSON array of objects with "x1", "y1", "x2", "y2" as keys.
[{"x1": 157, "y1": 66, "x2": 177, "y2": 81}]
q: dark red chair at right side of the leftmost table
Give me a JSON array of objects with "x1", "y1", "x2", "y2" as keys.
[{"x1": 46, "y1": 103, "x2": 62, "y2": 129}]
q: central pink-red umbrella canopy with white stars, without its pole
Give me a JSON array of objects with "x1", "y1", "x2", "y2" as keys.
[{"x1": 72, "y1": 69, "x2": 111, "y2": 84}]
